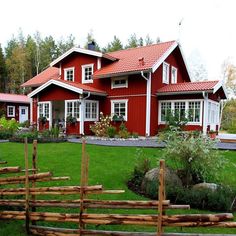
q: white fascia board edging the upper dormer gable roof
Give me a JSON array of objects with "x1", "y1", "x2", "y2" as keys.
[{"x1": 50, "y1": 47, "x2": 117, "y2": 66}]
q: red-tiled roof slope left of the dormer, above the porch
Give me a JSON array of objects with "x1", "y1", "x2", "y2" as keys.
[{"x1": 21, "y1": 67, "x2": 59, "y2": 87}]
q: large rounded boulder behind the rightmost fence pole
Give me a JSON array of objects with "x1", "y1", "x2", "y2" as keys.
[{"x1": 141, "y1": 167, "x2": 182, "y2": 198}]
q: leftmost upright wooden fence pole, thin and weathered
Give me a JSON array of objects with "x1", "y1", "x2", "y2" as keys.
[{"x1": 25, "y1": 138, "x2": 30, "y2": 234}]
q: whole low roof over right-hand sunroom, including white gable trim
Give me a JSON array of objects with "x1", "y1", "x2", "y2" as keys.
[{"x1": 157, "y1": 81, "x2": 227, "y2": 99}]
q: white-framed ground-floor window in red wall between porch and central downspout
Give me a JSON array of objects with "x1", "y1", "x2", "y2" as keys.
[{"x1": 111, "y1": 99, "x2": 128, "y2": 121}]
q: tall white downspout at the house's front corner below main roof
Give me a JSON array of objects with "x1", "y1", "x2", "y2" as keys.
[{"x1": 141, "y1": 71, "x2": 152, "y2": 136}]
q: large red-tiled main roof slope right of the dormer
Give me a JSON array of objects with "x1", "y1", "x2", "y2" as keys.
[{"x1": 93, "y1": 41, "x2": 176, "y2": 78}]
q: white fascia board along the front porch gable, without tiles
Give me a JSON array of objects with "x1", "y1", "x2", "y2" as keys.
[{"x1": 28, "y1": 79, "x2": 83, "y2": 98}]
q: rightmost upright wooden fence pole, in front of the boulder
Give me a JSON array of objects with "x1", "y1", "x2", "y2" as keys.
[{"x1": 157, "y1": 160, "x2": 165, "y2": 236}]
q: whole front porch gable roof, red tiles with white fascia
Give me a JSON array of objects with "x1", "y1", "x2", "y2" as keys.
[{"x1": 28, "y1": 79, "x2": 107, "y2": 98}]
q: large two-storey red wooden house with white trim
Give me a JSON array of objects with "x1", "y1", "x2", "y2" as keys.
[{"x1": 22, "y1": 41, "x2": 226, "y2": 136}]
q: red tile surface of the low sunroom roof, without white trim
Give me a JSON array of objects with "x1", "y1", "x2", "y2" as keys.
[{"x1": 157, "y1": 81, "x2": 219, "y2": 93}]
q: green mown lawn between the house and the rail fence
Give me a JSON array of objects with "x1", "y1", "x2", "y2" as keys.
[{"x1": 0, "y1": 143, "x2": 236, "y2": 236}]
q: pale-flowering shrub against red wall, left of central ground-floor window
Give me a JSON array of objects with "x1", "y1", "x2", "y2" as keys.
[{"x1": 90, "y1": 112, "x2": 111, "y2": 137}]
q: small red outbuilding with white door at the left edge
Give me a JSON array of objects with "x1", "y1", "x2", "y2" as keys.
[{"x1": 0, "y1": 93, "x2": 30, "y2": 123}]
